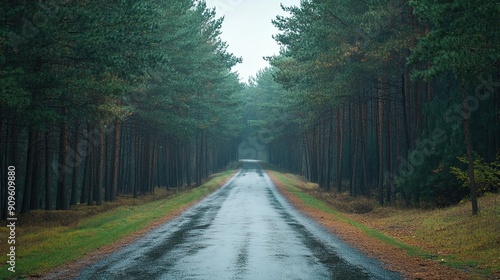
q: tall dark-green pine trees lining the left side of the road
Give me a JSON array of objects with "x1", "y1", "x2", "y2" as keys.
[{"x1": 0, "y1": 0, "x2": 242, "y2": 215}]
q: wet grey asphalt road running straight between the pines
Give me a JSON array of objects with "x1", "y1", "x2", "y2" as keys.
[{"x1": 78, "y1": 162, "x2": 399, "y2": 280}]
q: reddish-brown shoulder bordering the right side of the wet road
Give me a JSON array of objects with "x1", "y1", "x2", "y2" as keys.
[{"x1": 266, "y1": 170, "x2": 484, "y2": 279}]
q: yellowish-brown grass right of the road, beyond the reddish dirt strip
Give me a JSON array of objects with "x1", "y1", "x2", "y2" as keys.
[{"x1": 276, "y1": 174, "x2": 500, "y2": 279}]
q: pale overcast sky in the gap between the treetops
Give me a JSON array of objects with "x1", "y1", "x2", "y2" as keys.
[{"x1": 206, "y1": 0, "x2": 300, "y2": 82}]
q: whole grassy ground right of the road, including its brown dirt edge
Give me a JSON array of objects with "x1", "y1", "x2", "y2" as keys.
[{"x1": 267, "y1": 170, "x2": 500, "y2": 279}]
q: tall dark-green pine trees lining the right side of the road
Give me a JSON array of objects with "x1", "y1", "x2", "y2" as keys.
[{"x1": 254, "y1": 0, "x2": 500, "y2": 213}]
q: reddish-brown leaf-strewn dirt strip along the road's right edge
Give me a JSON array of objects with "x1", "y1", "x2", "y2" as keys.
[{"x1": 267, "y1": 171, "x2": 494, "y2": 280}]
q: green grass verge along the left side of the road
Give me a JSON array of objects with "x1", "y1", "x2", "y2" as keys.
[{"x1": 0, "y1": 169, "x2": 235, "y2": 279}]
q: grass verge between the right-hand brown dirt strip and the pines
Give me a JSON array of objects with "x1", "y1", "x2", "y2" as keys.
[{"x1": 268, "y1": 169, "x2": 500, "y2": 277}]
